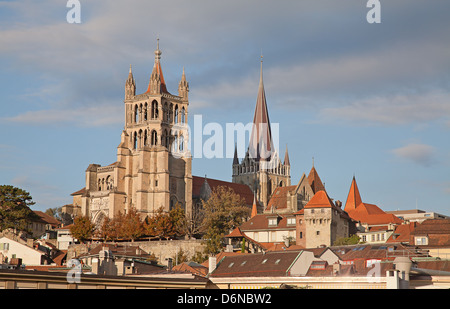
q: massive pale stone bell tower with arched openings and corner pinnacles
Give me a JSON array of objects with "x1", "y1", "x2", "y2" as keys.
[{"x1": 77, "y1": 39, "x2": 192, "y2": 224}]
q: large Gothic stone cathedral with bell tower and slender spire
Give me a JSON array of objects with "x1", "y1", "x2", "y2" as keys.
[{"x1": 72, "y1": 40, "x2": 310, "y2": 226}]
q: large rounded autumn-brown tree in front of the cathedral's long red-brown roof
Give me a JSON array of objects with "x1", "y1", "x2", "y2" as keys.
[{"x1": 202, "y1": 186, "x2": 250, "y2": 254}]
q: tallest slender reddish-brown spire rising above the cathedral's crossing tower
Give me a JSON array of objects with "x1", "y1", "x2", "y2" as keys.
[{"x1": 249, "y1": 55, "x2": 274, "y2": 161}]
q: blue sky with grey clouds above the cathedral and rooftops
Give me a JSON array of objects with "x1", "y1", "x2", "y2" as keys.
[{"x1": 0, "y1": 0, "x2": 450, "y2": 215}]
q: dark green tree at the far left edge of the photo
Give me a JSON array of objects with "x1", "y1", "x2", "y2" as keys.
[{"x1": 0, "y1": 185, "x2": 39, "y2": 232}]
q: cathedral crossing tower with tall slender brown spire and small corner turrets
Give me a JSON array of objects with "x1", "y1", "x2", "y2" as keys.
[{"x1": 232, "y1": 56, "x2": 291, "y2": 209}]
